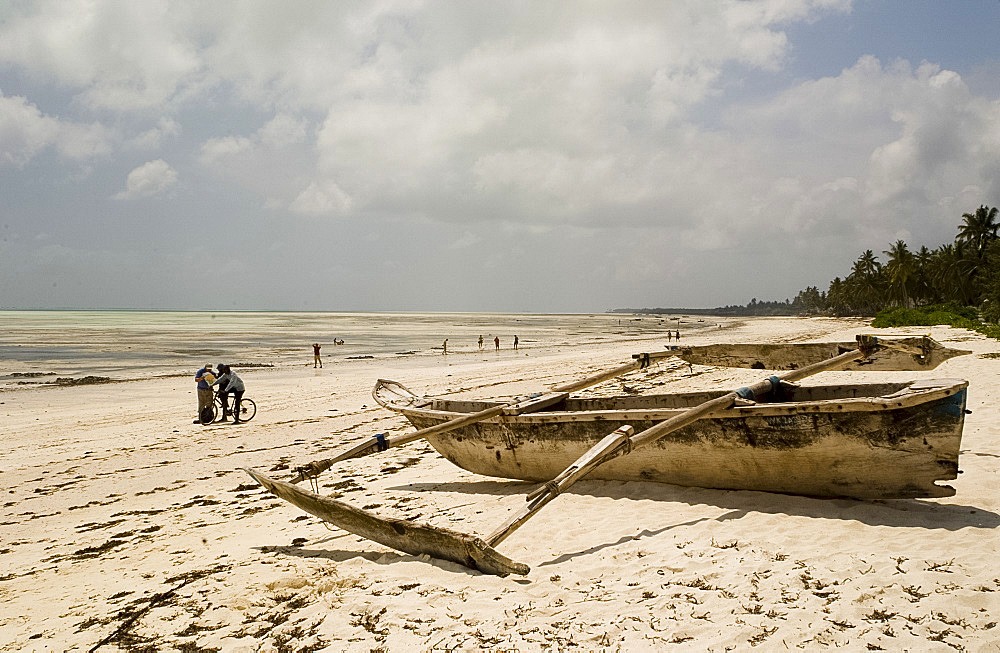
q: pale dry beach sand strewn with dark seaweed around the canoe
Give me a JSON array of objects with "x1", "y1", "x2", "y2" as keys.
[{"x1": 0, "y1": 319, "x2": 1000, "y2": 651}]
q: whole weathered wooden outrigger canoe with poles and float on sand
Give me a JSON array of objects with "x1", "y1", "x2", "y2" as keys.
[{"x1": 247, "y1": 336, "x2": 970, "y2": 575}]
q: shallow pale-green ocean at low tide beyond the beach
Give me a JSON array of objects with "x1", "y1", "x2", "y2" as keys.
[{"x1": 0, "y1": 310, "x2": 720, "y2": 389}]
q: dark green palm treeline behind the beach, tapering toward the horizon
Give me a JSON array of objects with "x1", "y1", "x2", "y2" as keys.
[{"x1": 611, "y1": 205, "x2": 1000, "y2": 324}]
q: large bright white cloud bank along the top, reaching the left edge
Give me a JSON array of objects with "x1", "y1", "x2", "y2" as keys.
[{"x1": 0, "y1": 0, "x2": 850, "y2": 223}]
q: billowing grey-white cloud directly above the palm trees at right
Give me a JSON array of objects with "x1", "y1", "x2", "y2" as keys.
[{"x1": 728, "y1": 56, "x2": 1000, "y2": 244}]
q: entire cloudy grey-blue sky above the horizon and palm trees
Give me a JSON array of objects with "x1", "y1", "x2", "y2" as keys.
[{"x1": 0, "y1": 0, "x2": 1000, "y2": 312}]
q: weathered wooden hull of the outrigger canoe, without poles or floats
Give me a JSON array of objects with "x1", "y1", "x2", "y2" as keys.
[{"x1": 388, "y1": 379, "x2": 968, "y2": 499}]
